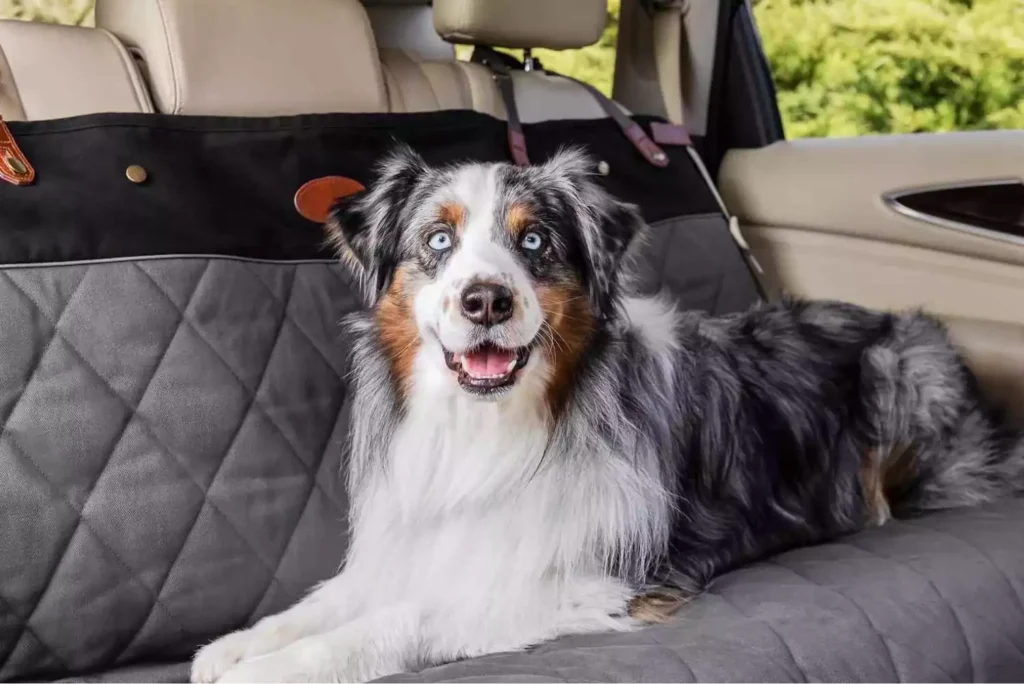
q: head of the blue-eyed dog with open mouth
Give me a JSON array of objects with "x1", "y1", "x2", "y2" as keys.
[{"x1": 328, "y1": 147, "x2": 643, "y2": 401}]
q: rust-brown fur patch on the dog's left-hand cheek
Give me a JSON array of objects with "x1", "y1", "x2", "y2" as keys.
[{"x1": 376, "y1": 265, "x2": 420, "y2": 398}]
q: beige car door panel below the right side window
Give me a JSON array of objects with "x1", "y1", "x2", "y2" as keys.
[{"x1": 719, "y1": 131, "x2": 1024, "y2": 419}]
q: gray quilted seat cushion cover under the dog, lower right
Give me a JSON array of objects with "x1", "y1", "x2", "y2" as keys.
[{"x1": 380, "y1": 500, "x2": 1024, "y2": 684}]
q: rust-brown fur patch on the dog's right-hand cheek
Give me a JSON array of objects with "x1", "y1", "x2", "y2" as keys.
[{"x1": 537, "y1": 283, "x2": 595, "y2": 416}]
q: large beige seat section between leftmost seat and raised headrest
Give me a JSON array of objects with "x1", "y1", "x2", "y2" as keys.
[{"x1": 96, "y1": 0, "x2": 387, "y2": 116}]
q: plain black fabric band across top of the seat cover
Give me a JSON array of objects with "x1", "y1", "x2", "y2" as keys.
[{"x1": 0, "y1": 112, "x2": 715, "y2": 263}]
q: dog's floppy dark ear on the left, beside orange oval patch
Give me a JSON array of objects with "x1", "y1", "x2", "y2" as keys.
[{"x1": 325, "y1": 145, "x2": 427, "y2": 305}]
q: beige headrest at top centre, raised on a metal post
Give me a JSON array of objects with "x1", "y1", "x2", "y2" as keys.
[{"x1": 434, "y1": 0, "x2": 607, "y2": 50}]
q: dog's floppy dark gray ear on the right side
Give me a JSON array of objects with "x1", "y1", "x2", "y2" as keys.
[{"x1": 543, "y1": 149, "x2": 646, "y2": 317}]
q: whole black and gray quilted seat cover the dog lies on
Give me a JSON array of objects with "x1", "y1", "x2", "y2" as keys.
[{"x1": 0, "y1": 108, "x2": 1024, "y2": 684}]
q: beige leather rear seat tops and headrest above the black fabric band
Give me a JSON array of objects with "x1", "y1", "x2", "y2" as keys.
[{"x1": 6, "y1": 0, "x2": 622, "y2": 123}]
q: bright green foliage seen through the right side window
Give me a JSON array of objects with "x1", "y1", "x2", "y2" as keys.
[{"x1": 755, "y1": 0, "x2": 1024, "y2": 137}]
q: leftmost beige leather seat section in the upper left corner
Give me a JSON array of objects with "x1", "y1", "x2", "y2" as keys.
[{"x1": 0, "y1": 22, "x2": 153, "y2": 121}]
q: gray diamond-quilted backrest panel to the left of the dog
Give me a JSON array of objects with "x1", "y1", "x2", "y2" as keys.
[{"x1": 0, "y1": 258, "x2": 358, "y2": 681}]
